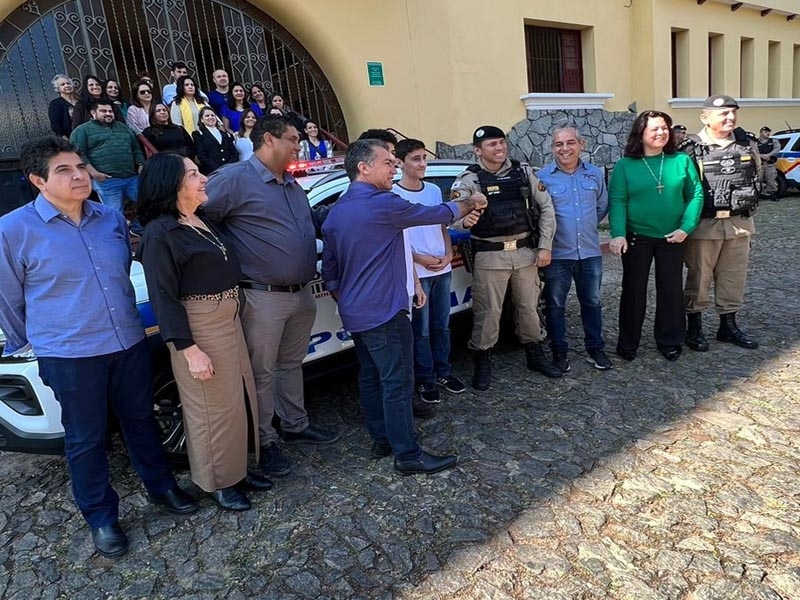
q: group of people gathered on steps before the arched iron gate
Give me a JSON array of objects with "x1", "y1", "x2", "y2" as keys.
[{"x1": 48, "y1": 61, "x2": 333, "y2": 210}]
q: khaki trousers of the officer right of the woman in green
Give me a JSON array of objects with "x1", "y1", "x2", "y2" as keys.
[{"x1": 684, "y1": 236, "x2": 750, "y2": 315}]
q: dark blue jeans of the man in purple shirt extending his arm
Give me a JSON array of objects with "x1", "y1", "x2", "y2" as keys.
[{"x1": 352, "y1": 311, "x2": 421, "y2": 460}]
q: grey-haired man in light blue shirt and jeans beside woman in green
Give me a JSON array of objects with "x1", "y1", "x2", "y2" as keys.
[{"x1": 538, "y1": 125, "x2": 612, "y2": 373}]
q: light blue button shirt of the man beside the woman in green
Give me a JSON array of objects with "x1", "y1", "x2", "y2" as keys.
[{"x1": 536, "y1": 160, "x2": 608, "y2": 260}]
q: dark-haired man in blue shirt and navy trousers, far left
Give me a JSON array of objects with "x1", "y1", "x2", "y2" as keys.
[{"x1": 0, "y1": 137, "x2": 197, "y2": 557}]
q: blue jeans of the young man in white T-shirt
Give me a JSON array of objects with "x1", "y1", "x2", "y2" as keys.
[{"x1": 411, "y1": 271, "x2": 453, "y2": 383}]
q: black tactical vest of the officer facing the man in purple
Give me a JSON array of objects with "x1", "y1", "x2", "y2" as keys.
[{"x1": 467, "y1": 160, "x2": 539, "y2": 238}]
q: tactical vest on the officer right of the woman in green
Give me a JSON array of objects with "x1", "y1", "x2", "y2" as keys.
[{"x1": 692, "y1": 136, "x2": 759, "y2": 217}]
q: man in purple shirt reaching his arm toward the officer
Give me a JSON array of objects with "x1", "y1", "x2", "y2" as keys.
[{"x1": 322, "y1": 139, "x2": 486, "y2": 475}]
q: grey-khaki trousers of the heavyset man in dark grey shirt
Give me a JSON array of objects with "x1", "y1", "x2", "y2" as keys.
[{"x1": 242, "y1": 286, "x2": 317, "y2": 446}]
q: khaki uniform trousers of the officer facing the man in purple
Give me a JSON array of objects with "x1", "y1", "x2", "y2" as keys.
[{"x1": 469, "y1": 254, "x2": 544, "y2": 350}]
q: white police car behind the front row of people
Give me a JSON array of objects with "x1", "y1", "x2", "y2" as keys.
[{"x1": 0, "y1": 160, "x2": 472, "y2": 455}]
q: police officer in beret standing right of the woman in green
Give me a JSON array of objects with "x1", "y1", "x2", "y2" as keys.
[{"x1": 684, "y1": 95, "x2": 761, "y2": 352}]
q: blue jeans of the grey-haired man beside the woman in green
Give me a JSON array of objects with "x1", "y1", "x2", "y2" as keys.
[{"x1": 544, "y1": 256, "x2": 605, "y2": 352}]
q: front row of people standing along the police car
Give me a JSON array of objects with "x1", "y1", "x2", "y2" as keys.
[{"x1": 0, "y1": 91, "x2": 760, "y2": 557}]
